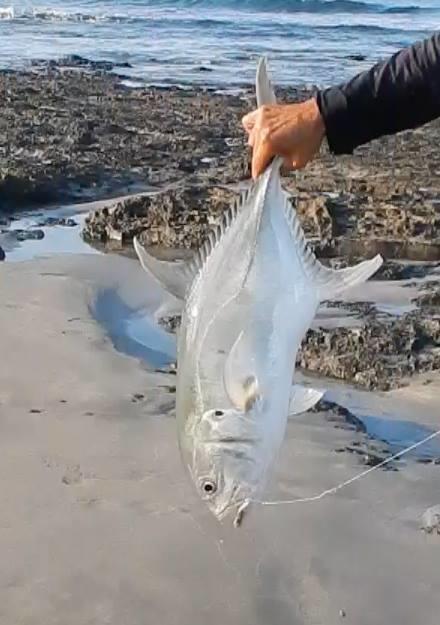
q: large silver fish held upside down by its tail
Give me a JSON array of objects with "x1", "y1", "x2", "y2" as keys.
[{"x1": 134, "y1": 58, "x2": 383, "y2": 527}]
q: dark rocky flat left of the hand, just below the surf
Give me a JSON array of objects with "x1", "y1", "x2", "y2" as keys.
[{"x1": 0, "y1": 63, "x2": 249, "y2": 213}]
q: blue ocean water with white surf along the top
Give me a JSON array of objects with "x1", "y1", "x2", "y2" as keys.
[{"x1": 0, "y1": 0, "x2": 440, "y2": 87}]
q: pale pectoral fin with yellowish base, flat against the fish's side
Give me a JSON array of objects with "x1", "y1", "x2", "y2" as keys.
[{"x1": 223, "y1": 330, "x2": 260, "y2": 412}]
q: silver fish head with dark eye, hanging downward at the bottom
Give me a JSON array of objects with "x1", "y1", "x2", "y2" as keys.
[{"x1": 187, "y1": 405, "x2": 268, "y2": 527}]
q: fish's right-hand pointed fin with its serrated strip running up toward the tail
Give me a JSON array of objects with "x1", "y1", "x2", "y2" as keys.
[{"x1": 283, "y1": 192, "x2": 383, "y2": 301}]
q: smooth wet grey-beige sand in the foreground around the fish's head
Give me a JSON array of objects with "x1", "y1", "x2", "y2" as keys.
[{"x1": 0, "y1": 255, "x2": 440, "y2": 625}]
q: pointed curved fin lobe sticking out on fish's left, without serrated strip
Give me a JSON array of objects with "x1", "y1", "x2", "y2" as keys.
[{"x1": 133, "y1": 237, "x2": 194, "y2": 300}]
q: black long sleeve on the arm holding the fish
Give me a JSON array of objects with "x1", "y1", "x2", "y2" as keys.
[{"x1": 317, "y1": 33, "x2": 440, "y2": 154}]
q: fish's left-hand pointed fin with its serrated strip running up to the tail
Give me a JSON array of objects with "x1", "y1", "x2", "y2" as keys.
[{"x1": 133, "y1": 187, "x2": 253, "y2": 300}]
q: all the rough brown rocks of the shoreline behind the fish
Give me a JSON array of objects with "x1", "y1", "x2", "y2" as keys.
[{"x1": 0, "y1": 57, "x2": 440, "y2": 390}]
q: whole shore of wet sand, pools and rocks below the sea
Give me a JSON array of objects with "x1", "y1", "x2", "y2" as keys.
[{"x1": 0, "y1": 54, "x2": 440, "y2": 625}]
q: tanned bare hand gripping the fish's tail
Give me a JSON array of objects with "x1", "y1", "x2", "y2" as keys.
[{"x1": 242, "y1": 98, "x2": 325, "y2": 179}]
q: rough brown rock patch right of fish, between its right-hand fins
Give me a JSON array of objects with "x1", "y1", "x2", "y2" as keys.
[{"x1": 157, "y1": 304, "x2": 440, "y2": 390}]
